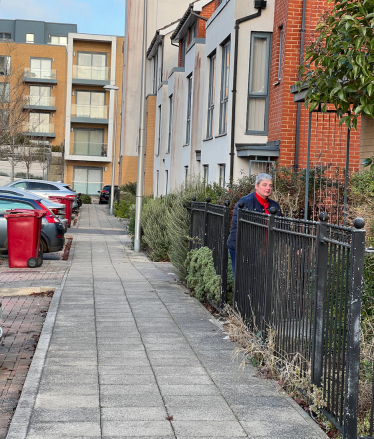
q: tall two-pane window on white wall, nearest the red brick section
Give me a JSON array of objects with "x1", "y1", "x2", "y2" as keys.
[{"x1": 247, "y1": 33, "x2": 270, "y2": 134}]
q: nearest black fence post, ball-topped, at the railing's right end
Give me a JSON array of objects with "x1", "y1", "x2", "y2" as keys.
[{"x1": 343, "y1": 218, "x2": 365, "y2": 439}]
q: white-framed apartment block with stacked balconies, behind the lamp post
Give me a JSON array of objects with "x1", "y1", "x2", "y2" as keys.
[{"x1": 65, "y1": 33, "x2": 123, "y2": 195}]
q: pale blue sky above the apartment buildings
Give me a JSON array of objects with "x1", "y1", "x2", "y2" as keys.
[{"x1": 0, "y1": 0, "x2": 126, "y2": 36}]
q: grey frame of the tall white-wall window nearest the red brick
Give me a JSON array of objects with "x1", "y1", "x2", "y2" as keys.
[{"x1": 245, "y1": 31, "x2": 272, "y2": 136}]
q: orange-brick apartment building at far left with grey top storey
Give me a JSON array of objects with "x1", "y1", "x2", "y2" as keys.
[{"x1": 0, "y1": 20, "x2": 77, "y2": 162}]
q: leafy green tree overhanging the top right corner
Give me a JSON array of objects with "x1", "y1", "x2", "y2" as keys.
[{"x1": 298, "y1": 0, "x2": 374, "y2": 129}]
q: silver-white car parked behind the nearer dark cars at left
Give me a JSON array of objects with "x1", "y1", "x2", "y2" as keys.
[{"x1": 5, "y1": 178, "x2": 79, "y2": 209}]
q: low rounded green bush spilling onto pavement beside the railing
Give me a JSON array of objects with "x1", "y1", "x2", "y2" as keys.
[{"x1": 186, "y1": 247, "x2": 221, "y2": 302}]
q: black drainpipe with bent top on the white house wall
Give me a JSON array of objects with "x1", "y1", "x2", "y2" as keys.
[{"x1": 230, "y1": 0, "x2": 266, "y2": 184}]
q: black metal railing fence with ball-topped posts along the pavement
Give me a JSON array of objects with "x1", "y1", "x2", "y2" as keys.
[{"x1": 190, "y1": 202, "x2": 365, "y2": 439}]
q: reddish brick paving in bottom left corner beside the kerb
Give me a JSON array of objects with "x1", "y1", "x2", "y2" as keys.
[{"x1": 0, "y1": 295, "x2": 52, "y2": 439}]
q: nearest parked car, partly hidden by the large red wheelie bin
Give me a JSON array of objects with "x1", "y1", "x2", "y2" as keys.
[{"x1": 0, "y1": 194, "x2": 65, "y2": 253}]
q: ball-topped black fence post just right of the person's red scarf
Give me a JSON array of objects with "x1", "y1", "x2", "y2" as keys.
[{"x1": 264, "y1": 207, "x2": 278, "y2": 336}]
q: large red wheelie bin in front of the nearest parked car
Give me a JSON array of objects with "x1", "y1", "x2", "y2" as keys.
[{"x1": 4, "y1": 209, "x2": 46, "y2": 268}]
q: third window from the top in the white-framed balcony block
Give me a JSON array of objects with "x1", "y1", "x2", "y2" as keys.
[{"x1": 74, "y1": 128, "x2": 107, "y2": 157}]
